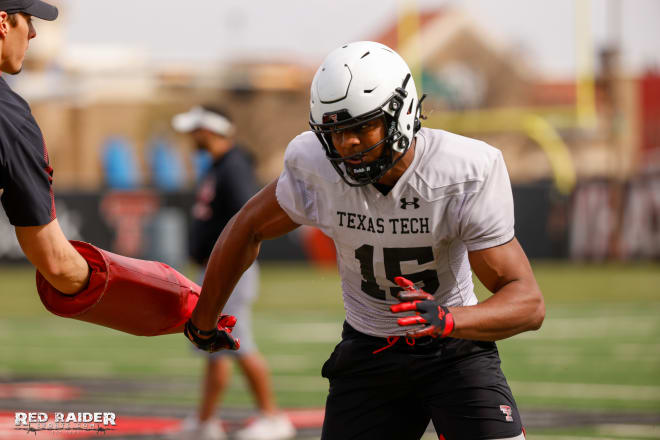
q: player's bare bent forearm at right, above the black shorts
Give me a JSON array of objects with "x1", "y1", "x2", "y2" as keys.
[{"x1": 449, "y1": 280, "x2": 545, "y2": 341}]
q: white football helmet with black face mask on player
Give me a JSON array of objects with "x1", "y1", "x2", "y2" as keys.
[{"x1": 309, "y1": 41, "x2": 424, "y2": 186}]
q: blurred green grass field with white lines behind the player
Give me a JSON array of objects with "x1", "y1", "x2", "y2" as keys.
[{"x1": 0, "y1": 262, "x2": 660, "y2": 440}]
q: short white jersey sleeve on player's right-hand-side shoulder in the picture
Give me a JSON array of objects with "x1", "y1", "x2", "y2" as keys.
[{"x1": 459, "y1": 150, "x2": 514, "y2": 251}]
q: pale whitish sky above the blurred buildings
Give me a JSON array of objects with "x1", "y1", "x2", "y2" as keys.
[{"x1": 49, "y1": 0, "x2": 660, "y2": 78}]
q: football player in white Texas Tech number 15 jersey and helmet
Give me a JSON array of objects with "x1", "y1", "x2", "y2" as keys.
[{"x1": 187, "y1": 42, "x2": 545, "y2": 440}]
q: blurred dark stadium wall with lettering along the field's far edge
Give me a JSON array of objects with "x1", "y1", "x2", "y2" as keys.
[{"x1": 0, "y1": 179, "x2": 660, "y2": 268}]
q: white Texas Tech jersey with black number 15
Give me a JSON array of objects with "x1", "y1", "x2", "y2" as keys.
[{"x1": 276, "y1": 128, "x2": 514, "y2": 337}]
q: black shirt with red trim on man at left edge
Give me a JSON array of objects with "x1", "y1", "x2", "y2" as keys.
[{"x1": 0, "y1": 77, "x2": 55, "y2": 226}]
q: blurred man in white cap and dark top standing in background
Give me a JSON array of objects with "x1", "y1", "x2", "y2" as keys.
[{"x1": 172, "y1": 106, "x2": 295, "y2": 440}]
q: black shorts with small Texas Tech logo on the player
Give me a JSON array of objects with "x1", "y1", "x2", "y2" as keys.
[{"x1": 321, "y1": 322, "x2": 522, "y2": 440}]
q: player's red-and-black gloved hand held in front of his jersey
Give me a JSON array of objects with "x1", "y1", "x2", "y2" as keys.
[{"x1": 390, "y1": 277, "x2": 454, "y2": 338}]
